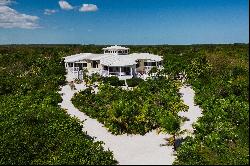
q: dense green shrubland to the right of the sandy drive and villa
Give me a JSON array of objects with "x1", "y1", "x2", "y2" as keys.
[{"x1": 131, "y1": 44, "x2": 249, "y2": 165}]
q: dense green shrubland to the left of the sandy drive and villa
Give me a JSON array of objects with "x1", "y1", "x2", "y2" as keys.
[{"x1": 0, "y1": 46, "x2": 117, "y2": 165}]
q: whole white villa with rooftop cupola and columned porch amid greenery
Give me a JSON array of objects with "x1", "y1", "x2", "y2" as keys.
[{"x1": 64, "y1": 45, "x2": 163, "y2": 79}]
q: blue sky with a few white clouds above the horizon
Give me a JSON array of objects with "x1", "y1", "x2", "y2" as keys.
[{"x1": 0, "y1": 0, "x2": 249, "y2": 45}]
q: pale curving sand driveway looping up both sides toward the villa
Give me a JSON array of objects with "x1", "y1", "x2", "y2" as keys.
[{"x1": 59, "y1": 76, "x2": 201, "y2": 165}]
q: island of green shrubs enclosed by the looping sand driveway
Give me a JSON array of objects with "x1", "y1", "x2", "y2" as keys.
[{"x1": 72, "y1": 77, "x2": 187, "y2": 135}]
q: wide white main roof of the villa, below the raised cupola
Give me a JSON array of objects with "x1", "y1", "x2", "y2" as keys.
[{"x1": 65, "y1": 53, "x2": 162, "y2": 66}]
